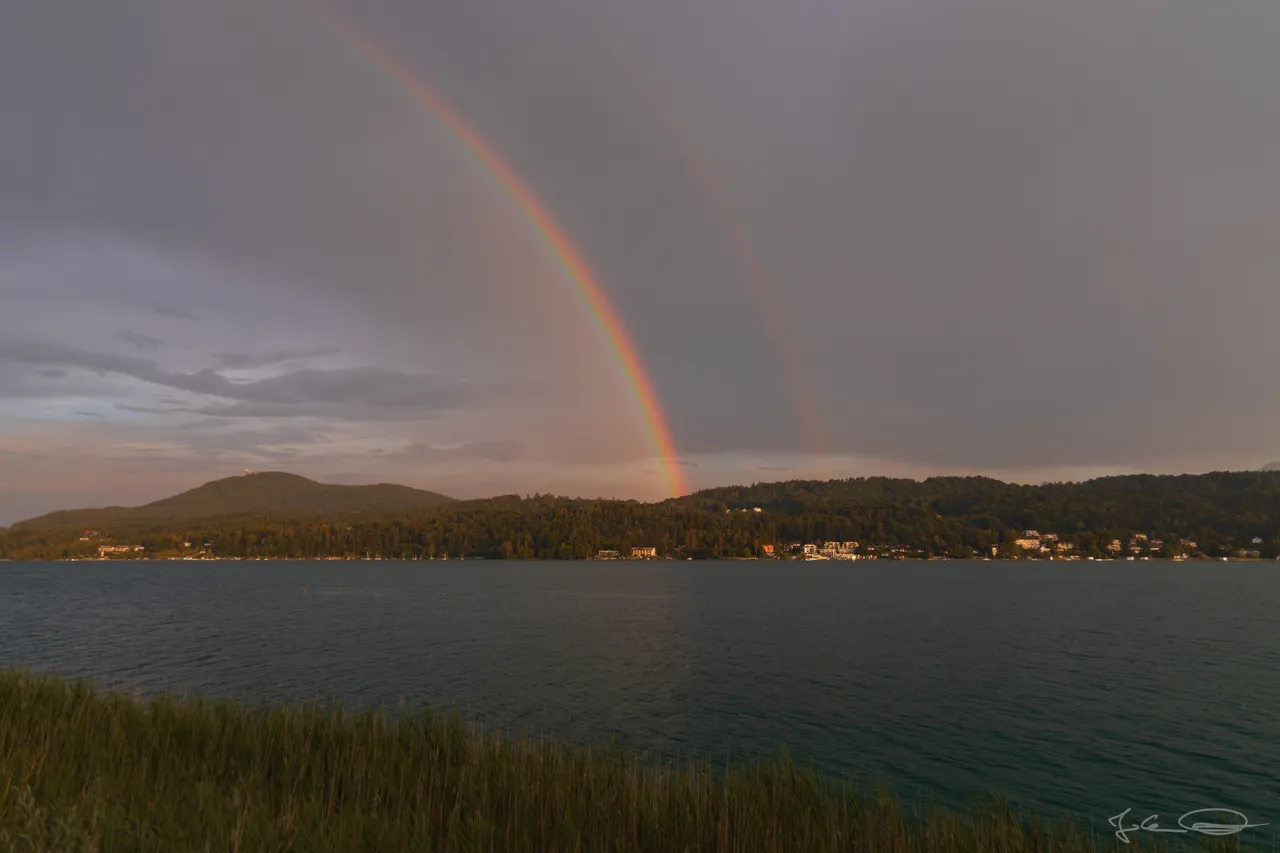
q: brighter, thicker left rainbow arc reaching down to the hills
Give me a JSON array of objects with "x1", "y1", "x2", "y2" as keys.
[{"x1": 302, "y1": 0, "x2": 686, "y2": 497}]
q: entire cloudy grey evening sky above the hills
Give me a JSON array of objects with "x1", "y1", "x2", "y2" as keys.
[{"x1": 0, "y1": 0, "x2": 1280, "y2": 524}]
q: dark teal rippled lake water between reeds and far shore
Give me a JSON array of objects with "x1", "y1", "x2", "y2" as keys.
[{"x1": 0, "y1": 561, "x2": 1280, "y2": 845}]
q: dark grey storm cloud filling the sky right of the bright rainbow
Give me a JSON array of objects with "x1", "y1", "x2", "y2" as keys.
[{"x1": 345, "y1": 0, "x2": 1280, "y2": 466}]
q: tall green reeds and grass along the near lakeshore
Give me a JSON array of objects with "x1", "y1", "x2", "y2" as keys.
[{"x1": 0, "y1": 671, "x2": 1236, "y2": 853}]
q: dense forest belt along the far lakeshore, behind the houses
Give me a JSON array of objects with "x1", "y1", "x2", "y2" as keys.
[{"x1": 0, "y1": 471, "x2": 1280, "y2": 560}]
